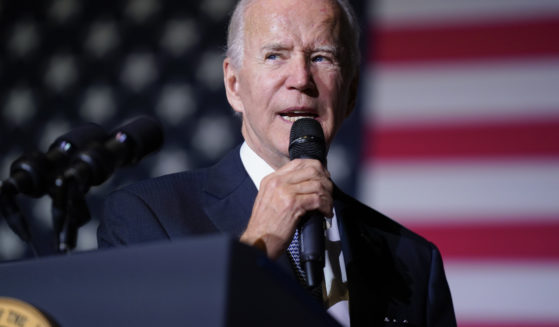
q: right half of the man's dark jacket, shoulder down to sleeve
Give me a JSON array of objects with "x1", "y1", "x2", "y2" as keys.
[{"x1": 335, "y1": 188, "x2": 456, "y2": 326}]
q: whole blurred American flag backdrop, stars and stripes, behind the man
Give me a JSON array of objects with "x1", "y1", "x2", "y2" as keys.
[{"x1": 0, "y1": 0, "x2": 559, "y2": 327}]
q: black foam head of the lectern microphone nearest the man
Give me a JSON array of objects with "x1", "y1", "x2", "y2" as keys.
[{"x1": 113, "y1": 116, "x2": 163, "y2": 164}]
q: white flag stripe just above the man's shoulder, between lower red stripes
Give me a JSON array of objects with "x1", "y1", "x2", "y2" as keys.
[{"x1": 358, "y1": 159, "x2": 559, "y2": 222}]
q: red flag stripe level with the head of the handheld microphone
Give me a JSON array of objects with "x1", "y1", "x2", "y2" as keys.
[{"x1": 365, "y1": 120, "x2": 559, "y2": 159}]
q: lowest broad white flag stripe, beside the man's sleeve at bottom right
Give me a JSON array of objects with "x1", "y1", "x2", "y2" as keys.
[{"x1": 445, "y1": 260, "x2": 559, "y2": 325}]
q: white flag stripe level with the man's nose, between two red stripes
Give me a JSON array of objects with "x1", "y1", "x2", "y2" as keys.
[{"x1": 365, "y1": 60, "x2": 559, "y2": 126}]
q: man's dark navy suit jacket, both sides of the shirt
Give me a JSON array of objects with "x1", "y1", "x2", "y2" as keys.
[{"x1": 98, "y1": 147, "x2": 456, "y2": 327}]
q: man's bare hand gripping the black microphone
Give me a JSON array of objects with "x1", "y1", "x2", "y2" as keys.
[{"x1": 240, "y1": 159, "x2": 333, "y2": 259}]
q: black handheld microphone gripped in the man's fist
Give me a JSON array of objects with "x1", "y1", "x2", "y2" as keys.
[{"x1": 289, "y1": 118, "x2": 326, "y2": 287}]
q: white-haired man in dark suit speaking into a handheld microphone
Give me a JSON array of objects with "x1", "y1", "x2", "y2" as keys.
[{"x1": 98, "y1": 0, "x2": 456, "y2": 327}]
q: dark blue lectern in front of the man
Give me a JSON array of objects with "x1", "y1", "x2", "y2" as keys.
[{"x1": 0, "y1": 236, "x2": 338, "y2": 327}]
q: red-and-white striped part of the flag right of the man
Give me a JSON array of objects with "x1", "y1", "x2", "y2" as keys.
[{"x1": 364, "y1": 0, "x2": 559, "y2": 327}]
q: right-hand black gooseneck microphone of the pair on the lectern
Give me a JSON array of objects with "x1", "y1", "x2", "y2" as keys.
[{"x1": 52, "y1": 116, "x2": 163, "y2": 252}]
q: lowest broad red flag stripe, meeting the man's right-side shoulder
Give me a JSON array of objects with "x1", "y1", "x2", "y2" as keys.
[{"x1": 407, "y1": 220, "x2": 559, "y2": 260}]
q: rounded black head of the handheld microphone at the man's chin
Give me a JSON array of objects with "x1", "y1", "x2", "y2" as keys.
[{"x1": 289, "y1": 118, "x2": 326, "y2": 164}]
